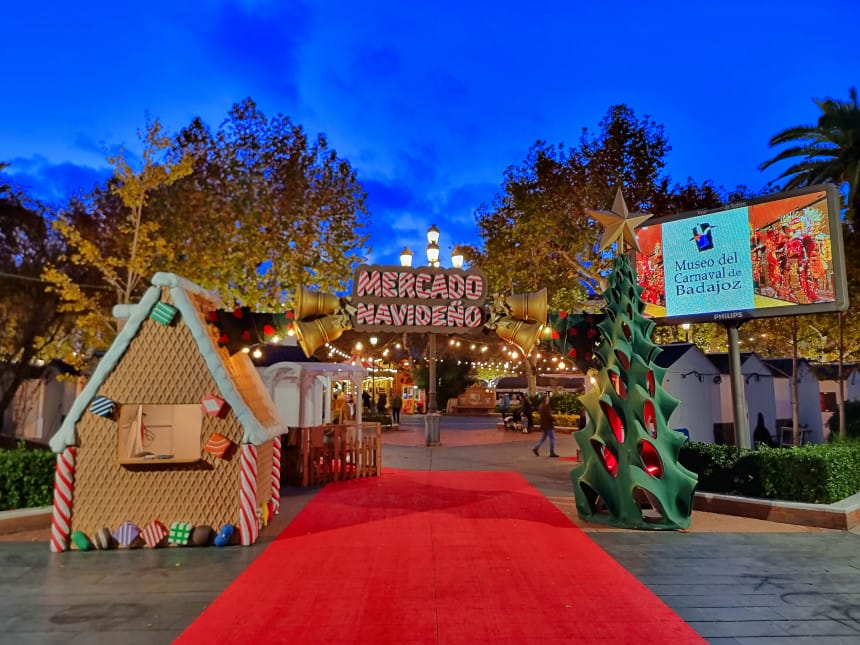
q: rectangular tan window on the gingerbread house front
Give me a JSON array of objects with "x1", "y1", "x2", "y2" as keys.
[{"x1": 117, "y1": 403, "x2": 203, "y2": 464}]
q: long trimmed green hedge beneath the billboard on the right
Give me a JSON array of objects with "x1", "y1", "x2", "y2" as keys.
[{"x1": 678, "y1": 442, "x2": 860, "y2": 504}]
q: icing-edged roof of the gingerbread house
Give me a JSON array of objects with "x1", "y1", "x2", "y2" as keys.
[{"x1": 50, "y1": 273, "x2": 287, "y2": 452}]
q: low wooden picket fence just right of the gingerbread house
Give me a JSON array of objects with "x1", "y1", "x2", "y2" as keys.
[{"x1": 281, "y1": 423, "x2": 382, "y2": 486}]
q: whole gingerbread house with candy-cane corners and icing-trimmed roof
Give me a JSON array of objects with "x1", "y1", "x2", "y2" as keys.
[{"x1": 50, "y1": 273, "x2": 287, "y2": 551}]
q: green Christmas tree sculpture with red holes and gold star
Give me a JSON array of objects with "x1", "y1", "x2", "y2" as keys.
[{"x1": 571, "y1": 190, "x2": 696, "y2": 529}]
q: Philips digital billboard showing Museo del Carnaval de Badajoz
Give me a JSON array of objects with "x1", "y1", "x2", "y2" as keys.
[{"x1": 635, "y1": 185, "x2": 848, "y2": 323}]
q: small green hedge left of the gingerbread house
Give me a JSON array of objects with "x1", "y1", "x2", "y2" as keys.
[{"x1": 0, "y1": 442, "x2": 57, "y2": 511}]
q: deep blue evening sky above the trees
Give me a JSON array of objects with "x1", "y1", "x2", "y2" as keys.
[{"x1": 0, "y1": 0, "x2": 860, "y2": 264}]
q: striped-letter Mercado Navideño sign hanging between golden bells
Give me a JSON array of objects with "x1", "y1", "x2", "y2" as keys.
[{"x1": 350, "y1": 265, "x2": 487, "y2": 334}]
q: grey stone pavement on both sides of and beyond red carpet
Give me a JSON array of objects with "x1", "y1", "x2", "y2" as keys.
[{"x1": 0, "y1": 416, "x2": 860, "y2": 645}]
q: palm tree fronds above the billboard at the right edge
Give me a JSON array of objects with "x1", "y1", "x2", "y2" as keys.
[{"x1": 760, "y1": 87, "x2": 860, "y2": 228}]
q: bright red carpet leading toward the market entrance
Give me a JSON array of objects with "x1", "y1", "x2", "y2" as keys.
[{"x1": 177, "y1": 470, "x2": 704, "y2": 645}]
